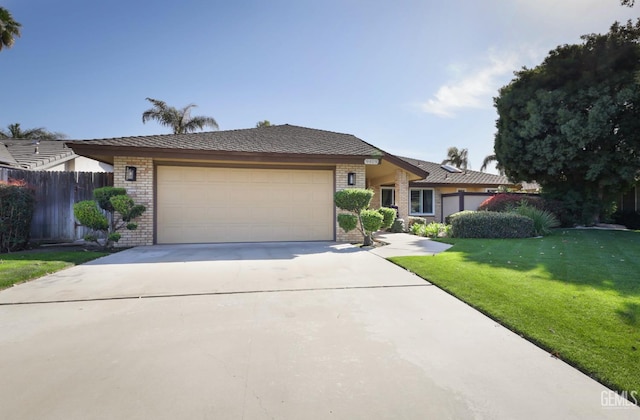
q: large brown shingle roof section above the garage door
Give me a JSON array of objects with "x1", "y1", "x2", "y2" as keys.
[{"x1": 68, "y1": 124, "x2": 380, "y2": 156}]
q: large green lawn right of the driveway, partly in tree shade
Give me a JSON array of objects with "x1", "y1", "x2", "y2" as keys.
[{"x1": 391, "y1": 229, "x2": 640, "y2": 398}]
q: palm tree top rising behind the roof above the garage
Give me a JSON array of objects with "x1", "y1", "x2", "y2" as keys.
[{"x1": 142, "y1": 98, "x2": 218, "y2": 134}]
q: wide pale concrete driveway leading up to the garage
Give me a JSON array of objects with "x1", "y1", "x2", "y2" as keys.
[{"x1": 0, "y1": 243, "x2": 640, "y2": 419}]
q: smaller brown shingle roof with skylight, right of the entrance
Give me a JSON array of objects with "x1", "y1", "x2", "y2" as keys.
[{"x1": 400, "y1": 157, "x2": 512, "y2": 186}]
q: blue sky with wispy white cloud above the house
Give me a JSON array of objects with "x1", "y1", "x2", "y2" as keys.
[{"x1": 0, "y1": 0, "x2": 640, "y2": 173}]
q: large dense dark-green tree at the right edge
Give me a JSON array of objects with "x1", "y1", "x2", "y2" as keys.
[{"x1": 494, "y1": 20, "x2": 640, "y2": 223}]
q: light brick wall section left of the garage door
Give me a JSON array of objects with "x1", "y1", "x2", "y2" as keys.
[{"x1": 113, "y1": 156, "x2": 154, "y2": 247}]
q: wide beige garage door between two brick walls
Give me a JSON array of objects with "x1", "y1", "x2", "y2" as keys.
[{"x1": 157, "y1": 166, "x2": 334, "y2": 244}]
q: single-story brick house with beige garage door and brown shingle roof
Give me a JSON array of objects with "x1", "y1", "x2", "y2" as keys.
[{"x1": 67, "y1": 124, "x2": 510, "y2": 246}]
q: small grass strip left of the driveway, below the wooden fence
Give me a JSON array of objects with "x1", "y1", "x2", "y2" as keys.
[{"x1": 0, "y1": 250, "x2": 109, "y2": 290}]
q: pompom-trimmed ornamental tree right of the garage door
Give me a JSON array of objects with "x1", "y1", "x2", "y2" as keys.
[{"x1": 334, "y1": 188, "x2": 384, "y2": 246}]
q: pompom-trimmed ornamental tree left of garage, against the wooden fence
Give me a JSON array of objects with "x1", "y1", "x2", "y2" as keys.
[{"x1": 73, "y1": 187, "x2": 146, "y2": 249}]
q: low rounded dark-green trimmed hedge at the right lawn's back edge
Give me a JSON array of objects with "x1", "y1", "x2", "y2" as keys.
[{"x1": 451, "y1": 211, "x2": 534, "y2": 238}]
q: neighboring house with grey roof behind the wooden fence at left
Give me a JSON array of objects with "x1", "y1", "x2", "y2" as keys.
[{"x1": 0, "y1": 139, "x2": 113, "y2": 172}]
